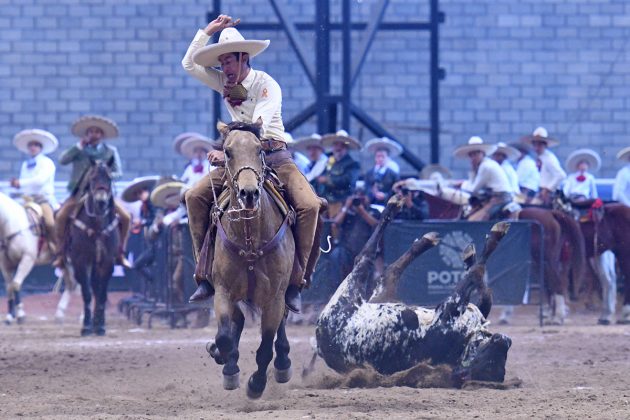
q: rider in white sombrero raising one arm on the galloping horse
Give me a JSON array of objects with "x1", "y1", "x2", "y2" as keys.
[{"x1": 182, "y1": 15, "x2": 321, "y2": 311}]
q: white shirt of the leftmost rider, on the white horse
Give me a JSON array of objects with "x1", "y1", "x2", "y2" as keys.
[{"x1": 19, "y1": 153, "x2": 59, "y2": 209}]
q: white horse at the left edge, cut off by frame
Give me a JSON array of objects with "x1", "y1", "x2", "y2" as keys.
[{"x1": 0, "y1": 192, "x2": 52, "y2": 324}]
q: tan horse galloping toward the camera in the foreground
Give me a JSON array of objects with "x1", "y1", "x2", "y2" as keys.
[{"x1": 208, "y1": 119, "x2": 295, "y2": 398}]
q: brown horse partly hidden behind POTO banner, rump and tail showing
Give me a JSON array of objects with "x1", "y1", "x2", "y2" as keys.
[{"x1": 424, "y1": 192, "x2": 585, "y2": 324}]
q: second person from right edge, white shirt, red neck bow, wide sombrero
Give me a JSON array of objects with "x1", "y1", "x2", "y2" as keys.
[{"x1": 562, "y1": 149, "x2": 601, "y2": 201}]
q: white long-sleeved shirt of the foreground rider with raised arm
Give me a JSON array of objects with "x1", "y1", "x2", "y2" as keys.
[{"x1": 182, "y1": 29, "x2": 286, "y2": 142}]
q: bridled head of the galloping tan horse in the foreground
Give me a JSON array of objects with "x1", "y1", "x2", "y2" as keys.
[{"x1": 217, "y1": 118, "x2": 265, "y2": 210}]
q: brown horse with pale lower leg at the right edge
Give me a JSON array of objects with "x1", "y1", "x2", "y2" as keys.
[{"x1": 579, "y1": 201, "x2": 630, "y2": 324}]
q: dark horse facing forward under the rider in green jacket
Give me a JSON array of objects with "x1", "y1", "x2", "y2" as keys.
[{"x1": 66, "y1": 161, "x2": 120, "y2": 336}]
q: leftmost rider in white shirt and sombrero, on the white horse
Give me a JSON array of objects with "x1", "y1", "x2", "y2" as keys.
[{"x1": 11, "y1": 128, "x2": 59, "y2": 255}]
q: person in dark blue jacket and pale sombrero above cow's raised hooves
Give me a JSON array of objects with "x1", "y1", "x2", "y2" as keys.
[{"x1": 363, "y1": 137, "x2": 402, "y2": 205}]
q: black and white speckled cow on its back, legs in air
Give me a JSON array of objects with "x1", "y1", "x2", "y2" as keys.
[{"x1": 316, "y1": 199, "x2": 511, "y2": 385}]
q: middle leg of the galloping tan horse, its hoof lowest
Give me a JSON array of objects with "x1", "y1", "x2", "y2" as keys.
[{"x1": 247, "y1": 300, "x2": 284, "y2": 398}]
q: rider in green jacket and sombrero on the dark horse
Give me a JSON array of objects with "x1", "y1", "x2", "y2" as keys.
[{"x1": 53, "y1": 115, "x2": 131, "y2": 268}]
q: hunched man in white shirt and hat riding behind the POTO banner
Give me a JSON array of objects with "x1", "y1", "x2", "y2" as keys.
[{"x1": 453, "y1": 136, "x2": 512, "y2": 221}]
